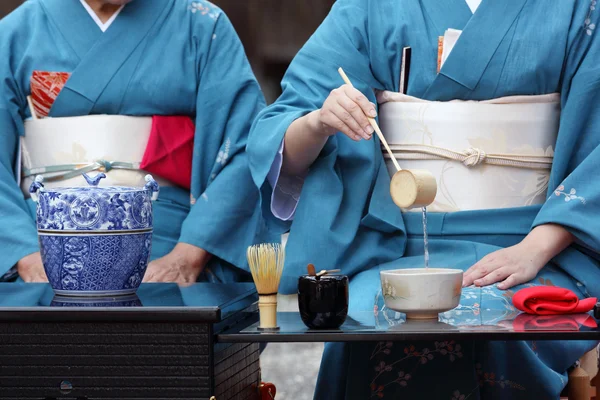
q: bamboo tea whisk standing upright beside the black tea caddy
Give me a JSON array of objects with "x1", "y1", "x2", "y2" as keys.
[{"x1": 247, "y1": 243, "x2": 285, "y2": 330}]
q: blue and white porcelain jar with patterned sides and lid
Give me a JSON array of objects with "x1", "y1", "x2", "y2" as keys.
[{"x1": 29, "y1": 173, "x2": 159, "y2": 296}]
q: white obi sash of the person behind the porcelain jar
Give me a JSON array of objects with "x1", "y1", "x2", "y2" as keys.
[{"x1": 20, "y1": 115, "x2": 173, "y2": 197}]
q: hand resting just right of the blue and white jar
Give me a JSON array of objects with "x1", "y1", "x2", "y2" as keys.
[{"x1": 144, "y1": 243, "x2": 210, "y2": 284}]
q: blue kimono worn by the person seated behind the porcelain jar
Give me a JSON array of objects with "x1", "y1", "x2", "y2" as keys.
[{"x1": 0, "y1": 0, "x2": 268, "y2": 282}]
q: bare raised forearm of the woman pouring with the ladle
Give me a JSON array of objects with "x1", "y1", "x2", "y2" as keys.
[{"x1": 281, "y1": 110, "x2": 331, "y2": 176}]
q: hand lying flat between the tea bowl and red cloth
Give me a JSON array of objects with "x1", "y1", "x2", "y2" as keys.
[{"x1": 463, "y1": 225, "x2": 574, "y2": 290}]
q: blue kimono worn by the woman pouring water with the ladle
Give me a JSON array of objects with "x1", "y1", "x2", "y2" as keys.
[{"x1": 248, "y1": 0, "x2": 600, "y2": 400}]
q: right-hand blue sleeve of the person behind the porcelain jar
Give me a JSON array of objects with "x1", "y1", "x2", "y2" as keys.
[{"x1": 179, "y1": 13, "x2": 265, "y2": 270}]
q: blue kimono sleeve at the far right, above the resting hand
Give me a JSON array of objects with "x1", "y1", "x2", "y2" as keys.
[{"x1": 534, "y1": 7, "x2": 600, "y2": 256}]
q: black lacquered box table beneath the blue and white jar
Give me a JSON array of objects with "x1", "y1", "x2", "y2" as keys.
[{"x1": 0, "y1": 283, "x2": 260, "y2": 400}]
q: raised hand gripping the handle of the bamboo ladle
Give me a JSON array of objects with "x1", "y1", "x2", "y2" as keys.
[{"x1": 311, "y1": 85, "x2": 377, "y2": 141}]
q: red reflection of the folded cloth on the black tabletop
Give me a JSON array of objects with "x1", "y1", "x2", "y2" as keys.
[{"x1": 513, "y1": 313, "x2": 598, "y2": 332}]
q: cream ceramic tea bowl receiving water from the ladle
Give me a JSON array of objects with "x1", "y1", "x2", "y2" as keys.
[{"x1": 380, "y1": 268, "x2": 463, "y2": 319}]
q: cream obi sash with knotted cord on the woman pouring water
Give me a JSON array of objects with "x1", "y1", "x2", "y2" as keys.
[{"x1": 377, "y1": 91, "x2": 560, "y2": 212}]
